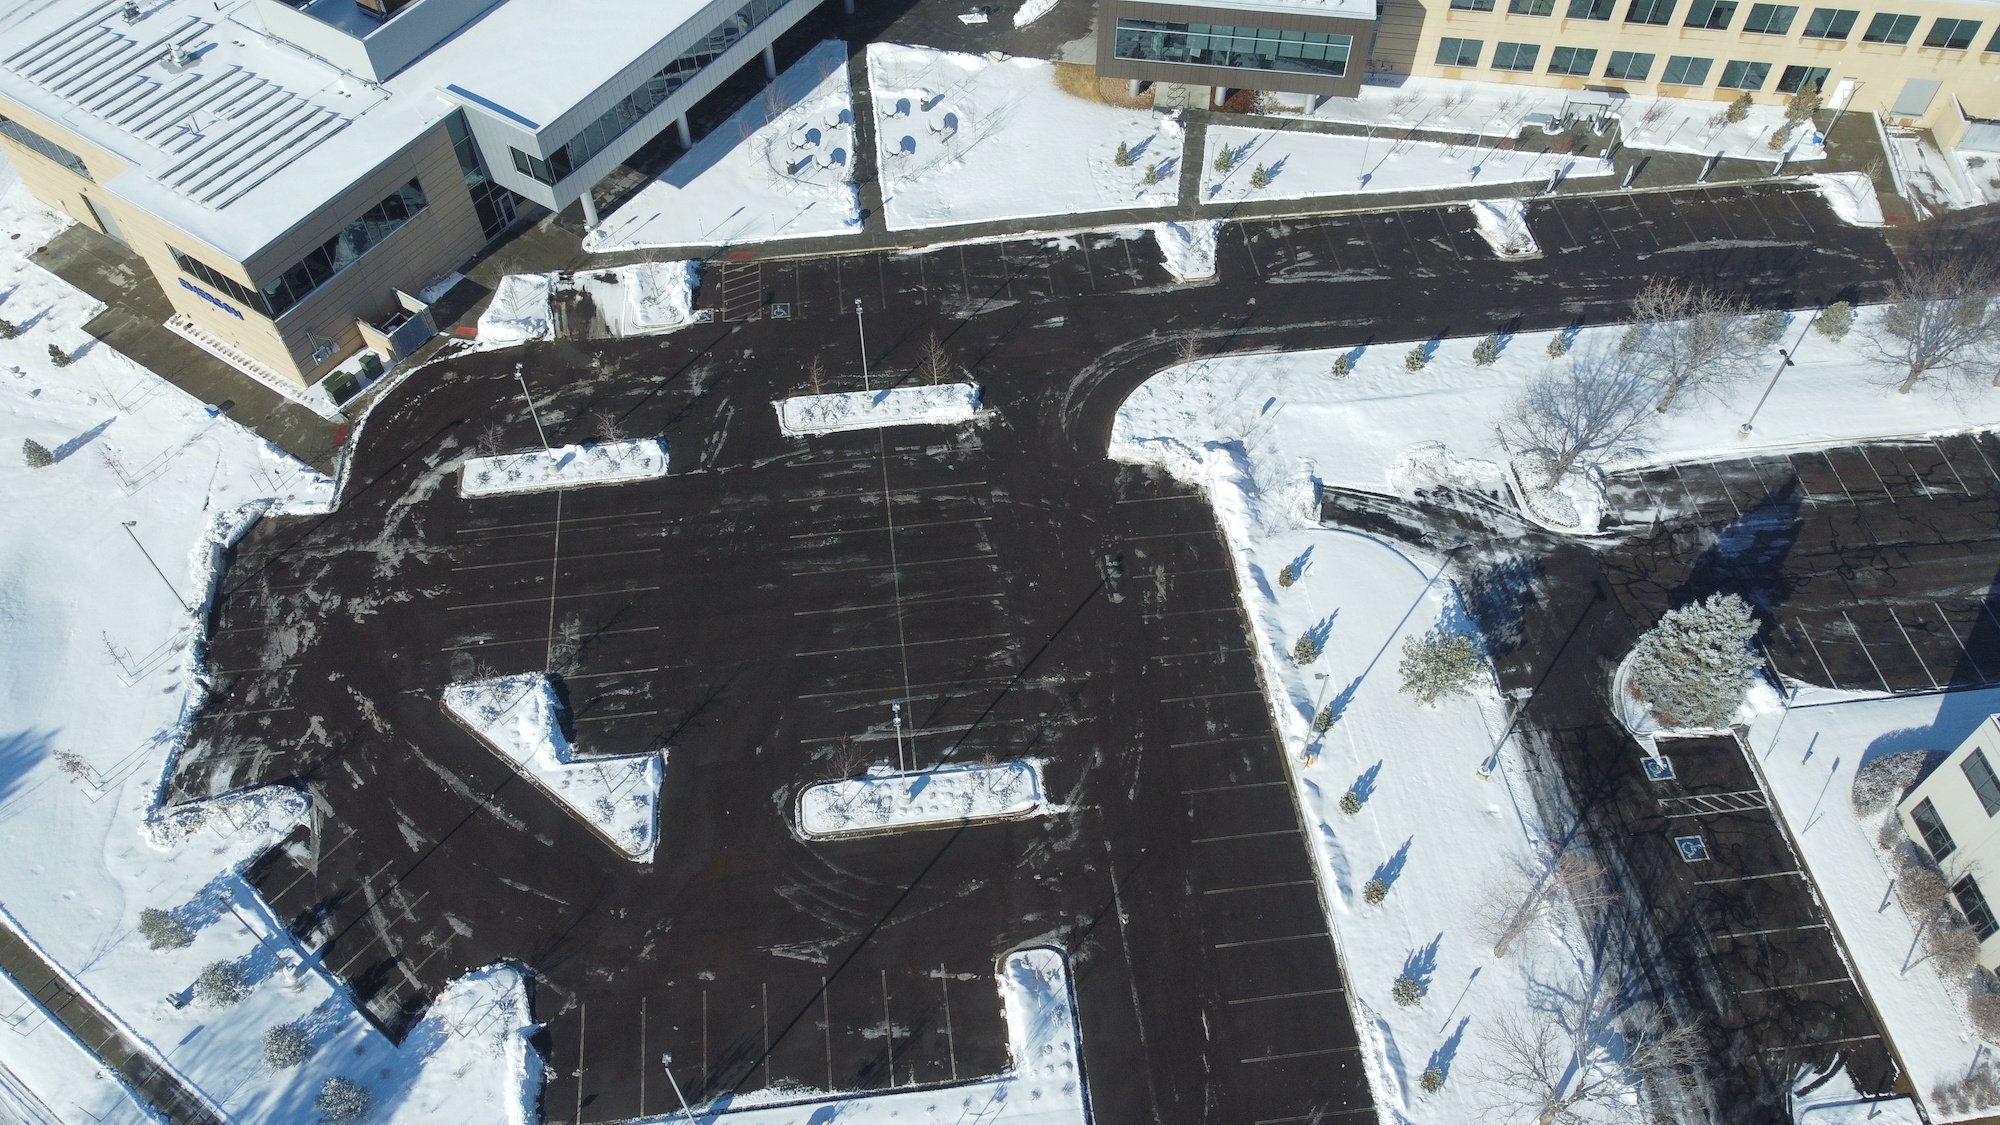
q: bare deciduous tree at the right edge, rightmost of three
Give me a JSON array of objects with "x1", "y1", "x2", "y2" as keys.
[{"x1": 1868, "y1": 254, "x2": 2000, "y2": 394}]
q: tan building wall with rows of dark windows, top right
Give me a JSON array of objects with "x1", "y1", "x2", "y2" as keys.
[{"x1": 1374, "y1": 0, "x2": 2000, "y2": 135}]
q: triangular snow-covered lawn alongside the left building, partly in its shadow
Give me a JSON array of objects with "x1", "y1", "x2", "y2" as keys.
[{"x1": 584, "y1": 40, "x2": 860, "y2": 254}]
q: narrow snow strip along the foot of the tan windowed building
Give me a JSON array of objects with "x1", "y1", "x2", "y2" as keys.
[{"x1": 1276, "y1": 78, "x2": 1826, "y2": 160}]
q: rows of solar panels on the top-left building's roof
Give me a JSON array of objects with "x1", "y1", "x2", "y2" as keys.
[{"x1": 4, "y1": 0, "x2": 350, "y2": 210}]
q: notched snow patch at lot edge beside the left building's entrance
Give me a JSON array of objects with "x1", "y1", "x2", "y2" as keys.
[{"x1": 478, "y1": 262, "x2": 702, "y2": 348}]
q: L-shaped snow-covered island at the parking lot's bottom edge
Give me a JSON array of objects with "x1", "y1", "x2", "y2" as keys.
[{"x1": 650, "y1": 947, "x2": 1080, "y2": 1125}]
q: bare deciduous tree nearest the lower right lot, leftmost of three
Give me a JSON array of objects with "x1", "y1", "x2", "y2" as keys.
[{"x1": 1506, "y1": 346, "x2": 1658, "y2": 488}]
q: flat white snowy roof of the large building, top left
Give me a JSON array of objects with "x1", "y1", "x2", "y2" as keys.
[{"x1": 0, "y1": 0, "x2": 720, "y2": 260}]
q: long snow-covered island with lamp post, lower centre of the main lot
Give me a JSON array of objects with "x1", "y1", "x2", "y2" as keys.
[{"x1": 798, "y1": 759, "x2": 1050, "y2": 839}]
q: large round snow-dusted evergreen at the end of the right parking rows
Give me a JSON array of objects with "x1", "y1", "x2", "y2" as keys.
[{"x1": 1628, "y1": 595, "x2": 1758, "y2": 727}]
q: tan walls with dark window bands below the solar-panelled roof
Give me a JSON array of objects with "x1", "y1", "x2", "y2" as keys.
[{"x1": 0, "y1": 98, "x2": 486, "y2": 384}]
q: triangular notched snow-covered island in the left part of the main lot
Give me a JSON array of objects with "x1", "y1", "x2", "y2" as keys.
[{"x1": 444, "y1": 673, "x2": 664, "y2": 863}]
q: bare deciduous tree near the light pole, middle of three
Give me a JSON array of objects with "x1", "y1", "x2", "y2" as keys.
[{"x1": 1622, "y1": 278, "x2": 1752, "y2": 414}]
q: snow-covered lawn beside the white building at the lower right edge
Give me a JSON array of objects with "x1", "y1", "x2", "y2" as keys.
[{"x1": 1748, "y1": 689, "x2": 2000, "y2": 1125}]
